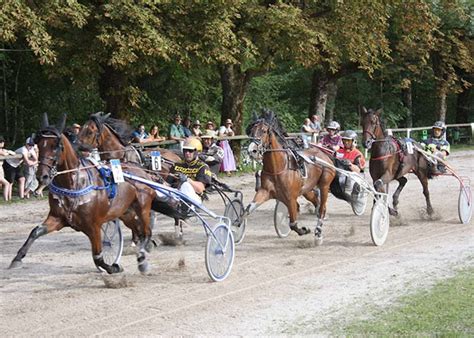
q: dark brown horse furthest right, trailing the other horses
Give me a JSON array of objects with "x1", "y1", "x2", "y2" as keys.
[{"x1": 361, "y1": 108, "x2": 433, "y2": 215}]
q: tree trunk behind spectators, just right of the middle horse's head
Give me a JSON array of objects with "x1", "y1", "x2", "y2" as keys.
[{"x1": 308, "y1": 70, "x2": 331, "y2": 123}]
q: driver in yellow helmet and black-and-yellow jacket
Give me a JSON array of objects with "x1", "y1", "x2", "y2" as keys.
[{"x1": 167, "y1": 137, "x2": 212, "y2": 203}]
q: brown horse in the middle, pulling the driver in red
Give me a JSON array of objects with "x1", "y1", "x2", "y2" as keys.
[{"x1": 246, "y1": 111, "x2": 336, "y2": 244}]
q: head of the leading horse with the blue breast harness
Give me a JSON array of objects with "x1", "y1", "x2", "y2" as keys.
[{"x1": 35, "y1": 113, "x2": 72, "y2": 185}]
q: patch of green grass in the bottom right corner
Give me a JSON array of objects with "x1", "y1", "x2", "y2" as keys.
[{"x1": 334, "y1": 268, "x2": 474, "y2": 337}]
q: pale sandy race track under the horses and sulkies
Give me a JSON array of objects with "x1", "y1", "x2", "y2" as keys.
[{"x1": 0, "y1": 151, "x2": 474, "y2": 336}]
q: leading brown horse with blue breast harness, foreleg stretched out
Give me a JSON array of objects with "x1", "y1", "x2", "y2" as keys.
[{"x1": 10, "y1": 114, "x2": 156, "y2": 273}]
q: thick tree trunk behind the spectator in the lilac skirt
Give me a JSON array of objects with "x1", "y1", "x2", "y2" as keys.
[{"x1": 219, "y1": 65, "x2": 253, "y2": 161}]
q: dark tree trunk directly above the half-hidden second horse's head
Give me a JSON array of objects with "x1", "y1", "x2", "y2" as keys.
[{"x1": 99, "y1": 66, "x2": 128, "y2": 120}]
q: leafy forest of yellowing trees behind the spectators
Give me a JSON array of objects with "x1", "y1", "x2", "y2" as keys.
[{"x1": 0, "y1": 0, "x2": 474, "y2": 145}]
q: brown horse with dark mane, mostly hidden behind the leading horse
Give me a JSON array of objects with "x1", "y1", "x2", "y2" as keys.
[{"x1": 78, "y1": 112, "x2": 182, "y2": 174}]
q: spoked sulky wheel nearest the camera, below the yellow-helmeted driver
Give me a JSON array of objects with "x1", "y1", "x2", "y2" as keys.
[{"x1": 206, "y1": 223, "x2": 235, "y2": 282}]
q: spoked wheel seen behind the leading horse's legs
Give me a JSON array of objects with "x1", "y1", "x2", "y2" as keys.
[{"x1": 100, "y1": 219, "x2": 123, "y2": 265}]
